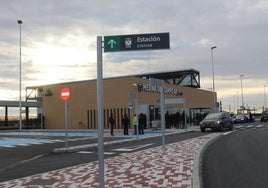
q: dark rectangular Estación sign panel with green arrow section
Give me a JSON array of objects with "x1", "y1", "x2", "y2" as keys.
[{"x1": 104, "y1": 33, "x2": 170, "y2": 52}]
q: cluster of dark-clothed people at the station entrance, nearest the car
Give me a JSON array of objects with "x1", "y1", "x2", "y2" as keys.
[{"x1": 165, "y1": 111, "x2": 185, "y2": 129}]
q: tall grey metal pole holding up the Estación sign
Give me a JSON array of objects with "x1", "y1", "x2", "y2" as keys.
[{"x1": 97, "y1": 36, "x2": 104, "y2": 188}]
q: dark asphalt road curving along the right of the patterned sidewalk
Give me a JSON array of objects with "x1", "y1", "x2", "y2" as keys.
[{"x1": 201, "y1": 123, "x2": 268, "y2": 188}]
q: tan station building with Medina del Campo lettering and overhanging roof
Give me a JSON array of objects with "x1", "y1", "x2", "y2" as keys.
[{"x1": 26, "y1": 69, "x2": 215, "y2": 129}]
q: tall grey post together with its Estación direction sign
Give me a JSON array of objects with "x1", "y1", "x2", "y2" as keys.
[{"x1": 97, "y1": 33, "x2": 170, "y2": 188}]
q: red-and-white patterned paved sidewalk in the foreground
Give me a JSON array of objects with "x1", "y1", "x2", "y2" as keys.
[{"x1": 0, "y1": 126, "x2": 219, "y2": 188}]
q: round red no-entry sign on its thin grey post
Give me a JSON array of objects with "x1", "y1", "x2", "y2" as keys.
[{"x1": 60, "y1": 87, "x2": 71, "y2": 149}]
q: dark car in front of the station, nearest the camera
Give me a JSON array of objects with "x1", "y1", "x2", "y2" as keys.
[{"x1": 200, "y1": 112, "x2": 233, "y2": 132}]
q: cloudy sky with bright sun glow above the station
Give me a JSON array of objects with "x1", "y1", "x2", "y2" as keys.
[{"x1": 0, "y1": 0, "x2": 268, "y2": 113}]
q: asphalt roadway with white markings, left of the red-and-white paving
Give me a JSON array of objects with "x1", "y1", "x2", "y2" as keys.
[{"x1": 0, "y1": 132, "x2": 207, "y2": 182}]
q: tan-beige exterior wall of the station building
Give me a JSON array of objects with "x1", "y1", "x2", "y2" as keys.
[{"x1": 43, "y1": 77, "x2": 213, "y2": 129}]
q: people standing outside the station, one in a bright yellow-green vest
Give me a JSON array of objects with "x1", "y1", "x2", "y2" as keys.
[{"x1": 109, "y1": 113, "x2": 147, "y2": 136}]
